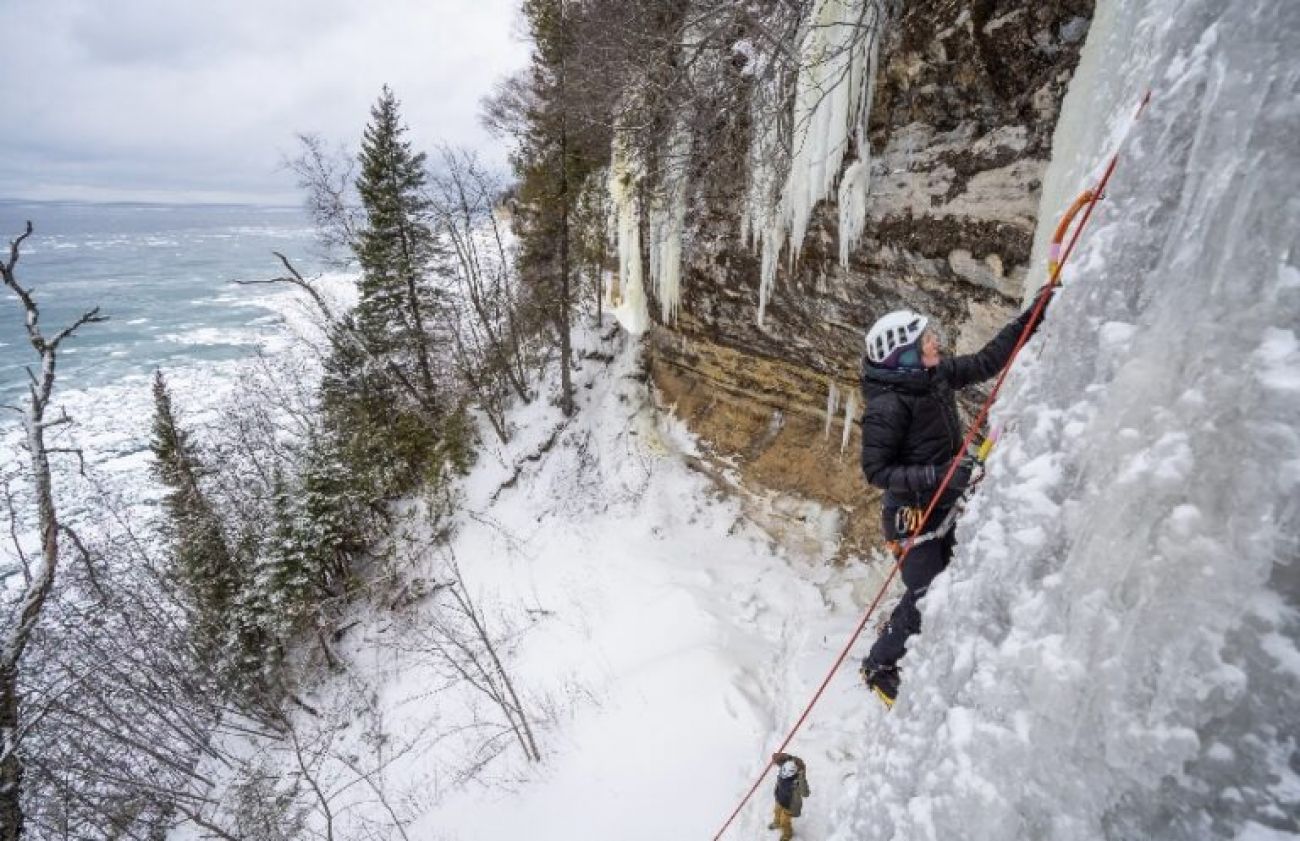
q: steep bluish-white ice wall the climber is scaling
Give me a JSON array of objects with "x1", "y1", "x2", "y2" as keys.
[{"x1": 832, "y1": 0, "x2": 1300, "y2": 841}]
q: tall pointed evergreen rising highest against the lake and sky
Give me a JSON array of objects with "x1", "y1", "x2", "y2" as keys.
[{"x1": 303, "y1": 86, "x2": 463, "y2": 512}]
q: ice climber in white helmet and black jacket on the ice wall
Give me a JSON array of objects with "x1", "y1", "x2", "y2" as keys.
[{"x1": 862, "y1": 291, "x2": 1043, "y2": 706}]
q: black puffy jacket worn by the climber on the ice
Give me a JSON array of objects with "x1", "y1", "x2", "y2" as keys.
[{"x1": 862, "y1": 307, "x2": 1034, "y2": 506}]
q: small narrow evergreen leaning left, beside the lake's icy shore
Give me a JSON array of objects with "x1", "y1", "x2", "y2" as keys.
[{"x1": 151, "y1": 370, "x2": 244, "y2": 655}]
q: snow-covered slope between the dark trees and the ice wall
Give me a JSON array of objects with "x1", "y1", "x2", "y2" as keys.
[{"x1": 172, "y1": 318, "x2": 881, "y2": 841}]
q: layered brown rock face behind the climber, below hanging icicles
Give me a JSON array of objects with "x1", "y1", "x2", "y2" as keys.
[{"x1": 650, "y1": 0, "x2": 1092, "y2": 558}]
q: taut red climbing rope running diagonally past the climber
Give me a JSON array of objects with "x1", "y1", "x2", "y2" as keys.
[{"x1": 714, "y1": 91, "x2": 1151, "y2": 841}]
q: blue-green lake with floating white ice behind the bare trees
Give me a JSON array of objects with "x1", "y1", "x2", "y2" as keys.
[{"x1": 0, "y1": 200, "x2": 350, "y2": 562}]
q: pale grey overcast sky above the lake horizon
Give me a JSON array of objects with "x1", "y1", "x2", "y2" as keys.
[{"x1": 0, "y1": 0, "x2": 528, "y2": 204}]
